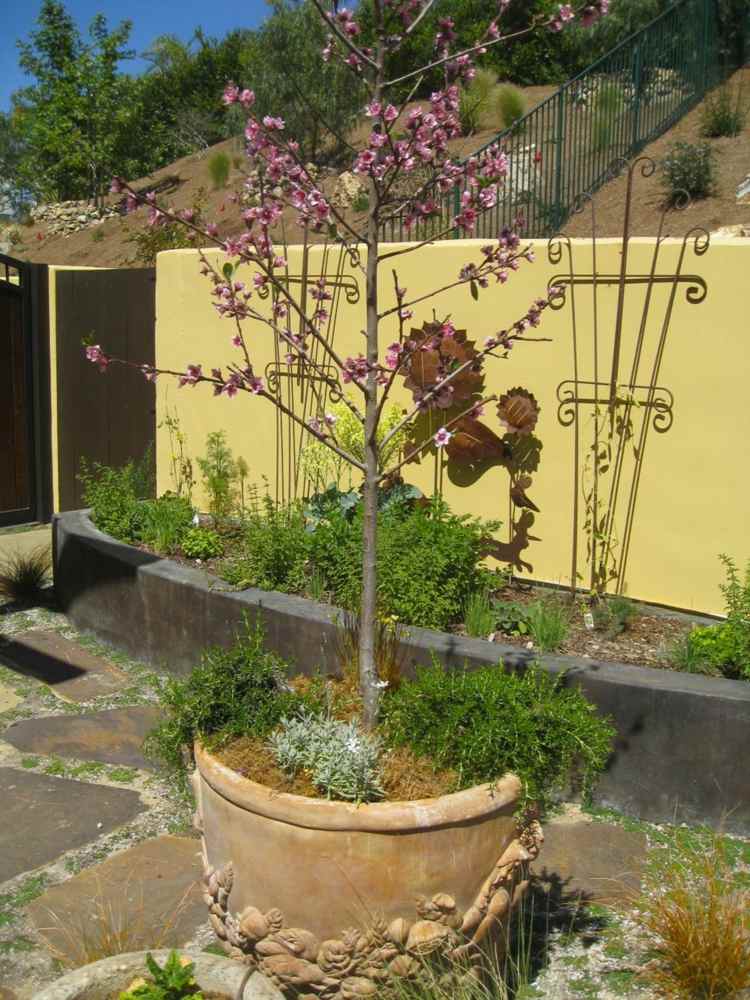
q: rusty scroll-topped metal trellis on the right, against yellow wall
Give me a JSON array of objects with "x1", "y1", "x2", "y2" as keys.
[{"x1": 547, "y1": 157, "x2": 709, "y2": 595}]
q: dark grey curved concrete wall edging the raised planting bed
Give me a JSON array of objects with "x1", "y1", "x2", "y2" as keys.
[{"x1": 53, "y1": 511, "x2": 750, "y2": 835}]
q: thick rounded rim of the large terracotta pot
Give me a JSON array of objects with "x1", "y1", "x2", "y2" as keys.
[{"x1": 194, "y1": 742, "x2": 521, "y2": 834}]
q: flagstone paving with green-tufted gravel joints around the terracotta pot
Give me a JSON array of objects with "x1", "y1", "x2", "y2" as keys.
[{"x1": 0, "y1": 592, "x2": 750, "y2": 1000}]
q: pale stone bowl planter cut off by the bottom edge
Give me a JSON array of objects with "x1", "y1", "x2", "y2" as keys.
[{"x1": 34, "y1": 951, "x2": 282, "y2": 1000}]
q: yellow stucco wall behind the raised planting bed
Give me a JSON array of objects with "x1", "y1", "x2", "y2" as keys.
[{"x1": 156, "y1": 239, "x2": 750, "y2": 613}]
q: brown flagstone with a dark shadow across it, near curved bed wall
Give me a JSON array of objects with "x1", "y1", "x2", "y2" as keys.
[{"x1": 0, "y1": 629, "x2": 128, "y2": 702}]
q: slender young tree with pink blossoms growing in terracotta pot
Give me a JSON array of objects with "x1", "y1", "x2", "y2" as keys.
[{"x1": 86, "y1": 0, "x2": 608, "y2": 726}]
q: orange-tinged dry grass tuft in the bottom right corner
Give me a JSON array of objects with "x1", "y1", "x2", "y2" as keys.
[{"x1": 641, "y1": 834, "x2": 750, "y2": 1000}]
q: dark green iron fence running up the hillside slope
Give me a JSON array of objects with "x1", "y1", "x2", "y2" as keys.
[{"x1": 382, "y1": 0, "x2": 750, "y2": 241}]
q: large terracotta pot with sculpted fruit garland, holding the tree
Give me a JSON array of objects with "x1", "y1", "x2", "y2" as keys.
[{"x1": 193, "y1": 746, "x2": 543, "y2": 998}]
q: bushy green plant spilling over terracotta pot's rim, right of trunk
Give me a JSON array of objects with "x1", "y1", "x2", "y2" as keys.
[{"x1": 382, "y1": 664, "x2": 614, "y2": 805}]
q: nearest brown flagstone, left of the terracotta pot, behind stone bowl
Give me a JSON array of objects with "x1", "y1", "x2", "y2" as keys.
[{"x1": 26, "y1": 835, "x2": 208, "y2": 952}]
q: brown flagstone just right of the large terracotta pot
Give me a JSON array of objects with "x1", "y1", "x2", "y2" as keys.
[{"x1": 533, "y1": 818, "x2": 647, "y2": 905}]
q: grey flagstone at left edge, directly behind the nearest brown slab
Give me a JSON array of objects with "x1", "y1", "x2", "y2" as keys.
[{"x1": 0, "y1": 767, "x2": 144, "y2": 882}]
